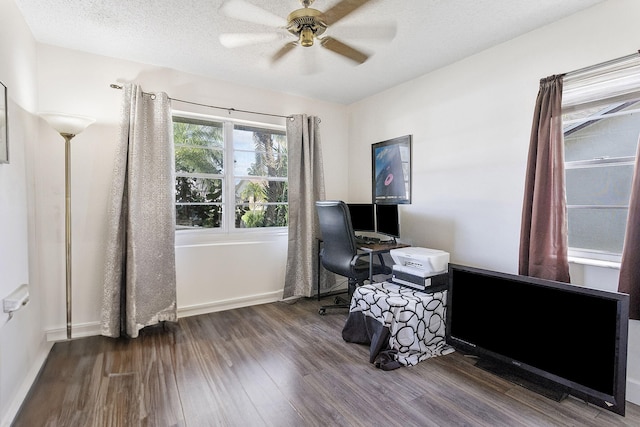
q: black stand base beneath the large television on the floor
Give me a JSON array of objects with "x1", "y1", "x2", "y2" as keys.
[{"x1": 475, "y1": 358, "x2": 569, "y2": 402}]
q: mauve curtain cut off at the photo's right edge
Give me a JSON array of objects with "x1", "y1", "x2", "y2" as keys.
[{"x1": 618, "y1": 135, "x2": 640, "y2": 320}]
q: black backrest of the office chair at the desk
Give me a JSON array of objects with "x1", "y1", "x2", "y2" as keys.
[{"x1": 316, "y1": 200, "x2": 358, "y2": 277}]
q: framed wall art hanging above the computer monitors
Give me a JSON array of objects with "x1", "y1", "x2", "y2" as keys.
[{"x1": 371, "y1": 135, "x2": 411, "y2": 205}]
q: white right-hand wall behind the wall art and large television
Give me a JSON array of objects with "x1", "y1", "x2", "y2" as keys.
[{"x1": 349, "y1": 0, "x2": 640, "y2": 403}]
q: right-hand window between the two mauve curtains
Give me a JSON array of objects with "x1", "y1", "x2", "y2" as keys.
[{"x1": 562, "y1": 53, "x2": 640, "y2": 262}]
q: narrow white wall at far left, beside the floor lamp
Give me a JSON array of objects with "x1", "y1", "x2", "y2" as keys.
[{"x1": 0, "y1": 0, "x2": 50, "y2": 425}]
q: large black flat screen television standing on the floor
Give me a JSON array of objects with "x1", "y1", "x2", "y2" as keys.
[{"x1": 446, "y1": 264, "x2": 629, "y2": 415}]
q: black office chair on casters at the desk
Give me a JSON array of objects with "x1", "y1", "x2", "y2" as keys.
[{"x1": 316, "y1": 200, "x2": 391, "y2": 314}]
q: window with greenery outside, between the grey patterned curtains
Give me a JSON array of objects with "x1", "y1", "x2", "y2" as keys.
[{"x1": 173, "y1": 115, "x2": 288, "y2": 231}]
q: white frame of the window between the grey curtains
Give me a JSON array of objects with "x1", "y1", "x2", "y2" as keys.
[{"x1": 172, "y1": 110, "x2": 288, "y2": 237}]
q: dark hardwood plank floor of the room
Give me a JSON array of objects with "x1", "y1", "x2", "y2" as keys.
[{"x1": 13, "y1": 299, "x2": 640, "y2": 427}]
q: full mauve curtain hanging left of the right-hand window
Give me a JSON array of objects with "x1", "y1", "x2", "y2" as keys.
[{"x1": 518, "y1": 75, "x2": 570, "y2": 283}]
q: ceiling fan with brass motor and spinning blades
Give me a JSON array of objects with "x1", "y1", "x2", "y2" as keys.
[{"x1": 220, "y1": 0, "x2": 395, "y2": 64}]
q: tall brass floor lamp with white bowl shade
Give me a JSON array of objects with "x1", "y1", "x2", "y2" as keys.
[{"x1": 40, "y1": 113, "x2": 95, "y2": 339}]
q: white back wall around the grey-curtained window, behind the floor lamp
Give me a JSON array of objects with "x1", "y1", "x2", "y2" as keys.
[{"x1": 35, "y1": 45, "x2": 347, "y2": 339}]
